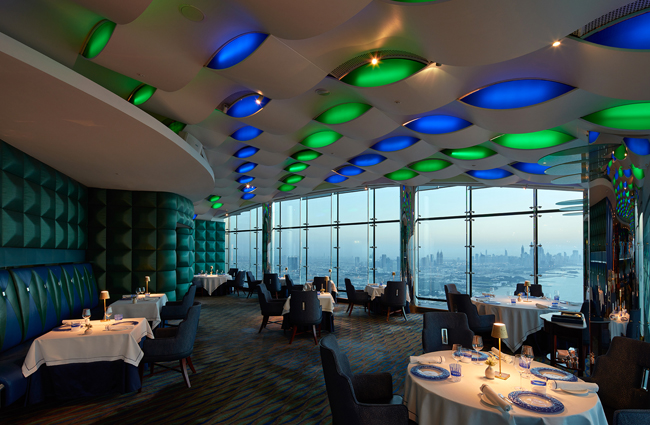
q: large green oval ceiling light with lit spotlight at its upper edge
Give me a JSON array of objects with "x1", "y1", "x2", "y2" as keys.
[{"x1": 341, "y1": 58, "x2": 427, "y2": 87}]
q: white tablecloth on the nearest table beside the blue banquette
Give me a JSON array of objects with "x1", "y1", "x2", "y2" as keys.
[{"x1": 23, "y1": 319, "x2": 153, "y2": 377}]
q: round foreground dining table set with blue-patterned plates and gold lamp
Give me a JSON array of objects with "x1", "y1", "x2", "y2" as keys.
[{"x1": 404, "y1": 351, "x2": 607, "y2": 425}]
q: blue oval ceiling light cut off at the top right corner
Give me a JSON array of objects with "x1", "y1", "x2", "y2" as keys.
[{"x1": 585, "y1": 12, "x2": 650, "y2": 50}]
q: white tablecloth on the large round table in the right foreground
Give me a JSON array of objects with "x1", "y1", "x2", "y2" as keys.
[{"x1": 404, "y1": 351, "x2": 607, "y2": 425}]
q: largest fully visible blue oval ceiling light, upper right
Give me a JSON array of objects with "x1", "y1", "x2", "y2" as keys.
[{"x1": 458, "y1": 80, "x2": 575, "y2": 109}]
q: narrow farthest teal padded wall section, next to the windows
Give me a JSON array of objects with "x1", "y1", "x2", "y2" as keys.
[{"x1": 194, "y1": 220, "x2": 226, "y2": 273}]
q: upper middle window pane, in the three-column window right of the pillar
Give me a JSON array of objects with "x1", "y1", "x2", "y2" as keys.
[{"x1": 472, "y1": 187, "x2": 534, "y2": 214}]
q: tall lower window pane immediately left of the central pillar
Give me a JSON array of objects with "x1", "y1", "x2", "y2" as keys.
[{"x1": 374, "y1": 223, "x2": 401, "y2": 283}]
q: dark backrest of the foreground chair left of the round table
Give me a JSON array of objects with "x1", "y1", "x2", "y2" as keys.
[{"x1": 318, "y1": 334, "x2": 361, "y2": 425}]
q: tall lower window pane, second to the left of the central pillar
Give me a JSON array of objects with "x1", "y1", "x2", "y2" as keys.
[{"x1": 338, "y1": 224, "x2": 368, "y2": 290}]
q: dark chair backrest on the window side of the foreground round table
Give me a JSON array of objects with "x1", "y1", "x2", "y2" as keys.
[{"x1": 422, "y1": 312, "x2": 474, "y2": 353}]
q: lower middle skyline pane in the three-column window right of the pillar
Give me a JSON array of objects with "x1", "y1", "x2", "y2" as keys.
[{"x1": 472, "y1": 215, "x2": 533, "y2": 295}]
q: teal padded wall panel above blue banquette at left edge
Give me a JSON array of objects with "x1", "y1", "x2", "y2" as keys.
[{"x1": 0, "y1": 140, "x2": 87, "y2": 267}]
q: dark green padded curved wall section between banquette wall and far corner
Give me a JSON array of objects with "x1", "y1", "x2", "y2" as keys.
[{"x1": 87, "y1": 189, "x2": 194, "y2": 301}]
